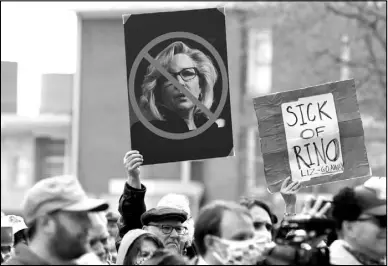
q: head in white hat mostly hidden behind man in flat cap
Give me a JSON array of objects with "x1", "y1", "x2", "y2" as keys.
[{"x1": 156, "y1": 193, "x2": 194, "y2": 254}]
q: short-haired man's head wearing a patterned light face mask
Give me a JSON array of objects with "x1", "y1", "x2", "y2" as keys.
[{"x1": 194, "y1": 201, "x2": 256, "y2": 264}]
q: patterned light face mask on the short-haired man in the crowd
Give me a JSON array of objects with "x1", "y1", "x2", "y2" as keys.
[{"x1": 212, "y1": 237, "x2": 269, "y2": 265}]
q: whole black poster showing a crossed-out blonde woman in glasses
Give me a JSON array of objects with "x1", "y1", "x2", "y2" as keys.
[{"x1": 123, "y1": 8, "x2": 233, "y2": 165}]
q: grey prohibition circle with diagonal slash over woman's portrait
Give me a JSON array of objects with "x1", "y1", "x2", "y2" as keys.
[{"x1": 128, "y1": 32, "x2": 228, "y2": 140}]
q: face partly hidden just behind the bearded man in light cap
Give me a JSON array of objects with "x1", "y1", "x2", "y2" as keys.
[{"x1": 88, "y1": 212, "x2": 110, "y2": 262}]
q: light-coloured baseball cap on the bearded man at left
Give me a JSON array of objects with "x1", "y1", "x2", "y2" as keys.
[{"x1": 22, "y1": 175, "x2": 109, "y2": 224}]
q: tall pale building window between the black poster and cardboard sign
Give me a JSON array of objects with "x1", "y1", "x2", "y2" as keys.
[{"x1": 247, "y1": 29, "x2": 273, "y2": 97}]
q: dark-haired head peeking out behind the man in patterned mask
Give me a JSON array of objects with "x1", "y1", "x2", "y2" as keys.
[{"x1": 240, "y1": 198, "x2": 278, "y2": 239}]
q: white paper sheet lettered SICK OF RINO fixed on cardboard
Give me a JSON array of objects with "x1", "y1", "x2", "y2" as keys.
[{"x1": 281, "y1": 93, "x2": 343, "y2": 181}]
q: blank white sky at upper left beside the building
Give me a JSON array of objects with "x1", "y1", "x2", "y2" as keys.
[{"x1": 1, "y1": 2, "x2": 224, "y2": 116}]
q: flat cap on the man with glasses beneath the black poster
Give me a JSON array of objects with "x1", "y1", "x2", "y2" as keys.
[{"x1": 141, "y1": 207, "x2": 187, "y2": 225}]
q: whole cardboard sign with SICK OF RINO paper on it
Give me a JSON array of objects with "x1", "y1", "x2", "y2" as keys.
[{"x1": 254, "y1": 80, "x2": 371, "y2": 192}]
